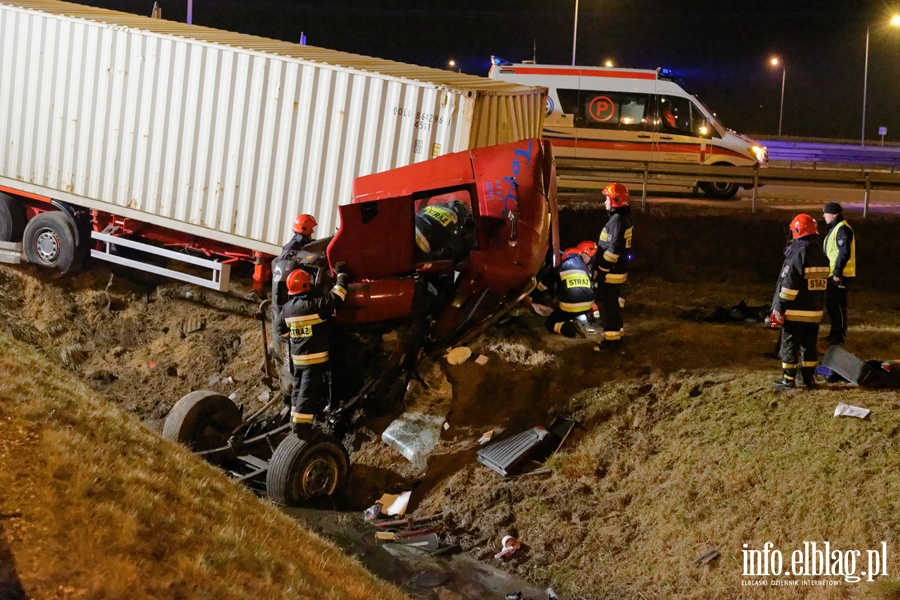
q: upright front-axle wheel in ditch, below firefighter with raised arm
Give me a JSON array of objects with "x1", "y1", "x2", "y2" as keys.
[{"x1": 266, "y1": 432, "x2": 350, "y2": 506}]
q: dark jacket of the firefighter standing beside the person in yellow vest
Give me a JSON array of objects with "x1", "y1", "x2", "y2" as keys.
[{"x1": 772, "y1": 235, "x2": 829, "y2": 323}]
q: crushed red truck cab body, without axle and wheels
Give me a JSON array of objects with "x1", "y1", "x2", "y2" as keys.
[{"x1": 327, "y1": 139, "x2": 558, "y2": 341}]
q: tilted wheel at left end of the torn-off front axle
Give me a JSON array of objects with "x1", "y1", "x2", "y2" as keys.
[{"x1": 163, "y1": 390, "x2": 241, "y2": 452}]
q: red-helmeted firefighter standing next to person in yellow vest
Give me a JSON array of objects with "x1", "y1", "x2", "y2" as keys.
[{"x1": 770, "y1": 214, "x2": 829, "y2": 389}]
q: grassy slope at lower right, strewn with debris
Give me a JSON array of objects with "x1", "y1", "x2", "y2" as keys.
[{"x1": 426, "y1": 372, "x2": 900, "y2": 600}]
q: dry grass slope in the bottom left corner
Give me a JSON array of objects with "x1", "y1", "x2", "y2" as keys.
[{"x1": 0, "y1": 333, "x2": 405, "y2": 600}]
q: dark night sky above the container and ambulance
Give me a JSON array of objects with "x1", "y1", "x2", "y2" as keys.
[{"x1": 67, "y1": 0, "x2": 900, "y2": 143}]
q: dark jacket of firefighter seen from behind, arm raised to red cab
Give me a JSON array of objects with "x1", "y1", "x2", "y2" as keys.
[{"x1": 281, "y1": 273, "x2": 348, "y2": 368}]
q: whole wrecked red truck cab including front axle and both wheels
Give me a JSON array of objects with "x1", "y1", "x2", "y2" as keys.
[{"x1": 163, "y1": 139, "x2": 559, "y2": 505}]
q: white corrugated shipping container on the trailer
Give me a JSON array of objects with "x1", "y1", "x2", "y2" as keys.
[{"x1": 0, "y1": 0, "x2": 546, "y2": 254}]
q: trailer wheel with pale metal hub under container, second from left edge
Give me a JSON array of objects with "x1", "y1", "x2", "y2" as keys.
[{"x1": 22, "y1": 210, "x2": 78, "y2": 275}]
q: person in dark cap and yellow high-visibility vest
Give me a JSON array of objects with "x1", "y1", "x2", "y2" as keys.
[{"x1": 823, "y1": 202, "x2": 856, "y2": 345}]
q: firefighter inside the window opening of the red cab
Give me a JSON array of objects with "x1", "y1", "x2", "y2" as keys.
[{"x1": 416, "y1": 200, "x2": 475, "y2": 262}]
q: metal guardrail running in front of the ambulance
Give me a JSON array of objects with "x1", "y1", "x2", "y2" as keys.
[{"x1": 556, "y1": 158, "x2": 900, "y2": 217}]
